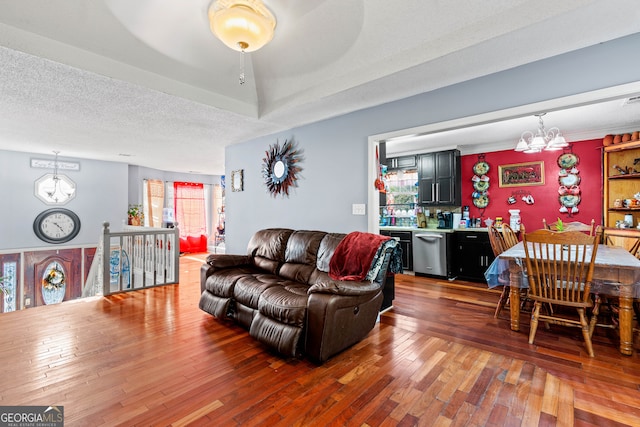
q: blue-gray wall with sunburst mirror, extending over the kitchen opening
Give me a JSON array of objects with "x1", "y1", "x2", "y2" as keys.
[{"x1": 225, "y1": 34, "x2": 640, "y2": 253}]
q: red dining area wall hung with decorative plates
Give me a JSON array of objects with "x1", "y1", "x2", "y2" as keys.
[{"x1": 461, "y1": 139, "x2": 603, "y2": 234}]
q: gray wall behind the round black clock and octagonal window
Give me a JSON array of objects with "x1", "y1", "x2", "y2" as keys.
[{"x1": 0, "y1": 151, "x2": 128, "y2": 250}]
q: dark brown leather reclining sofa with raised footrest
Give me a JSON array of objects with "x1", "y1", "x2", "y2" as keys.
[{"x1": 199, "y1": 228, "x2": 396, "y2": 363}]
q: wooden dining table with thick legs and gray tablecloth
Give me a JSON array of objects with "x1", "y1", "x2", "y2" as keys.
[{"x1": 485, "y1": 242, "x2": 640, "y2": 355}]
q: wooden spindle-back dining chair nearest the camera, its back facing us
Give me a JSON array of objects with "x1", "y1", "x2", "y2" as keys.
[{"x1": 522, "y1": 229, "x2": 600, "y2": 357}]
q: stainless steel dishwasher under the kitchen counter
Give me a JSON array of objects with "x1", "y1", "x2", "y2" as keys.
[{"x1": 412, "y1": 230, "x2": 449, "y2": 277}]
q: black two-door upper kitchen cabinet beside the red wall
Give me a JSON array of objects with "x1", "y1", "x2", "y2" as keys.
[{"x1": 418, "y1": 150, "x2": 462, "y2": 206}]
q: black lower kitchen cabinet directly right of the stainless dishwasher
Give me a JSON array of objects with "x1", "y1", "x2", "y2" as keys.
[{"x1": 453, "y1": 231, "x2": 495, "y2": 283}]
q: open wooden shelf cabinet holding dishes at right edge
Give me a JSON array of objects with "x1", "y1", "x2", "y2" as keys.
[{"x1": 604, "y1": 141, "x2": 640, "y2": 227}]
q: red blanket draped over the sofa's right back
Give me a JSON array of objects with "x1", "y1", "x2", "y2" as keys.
[{"x1": 329, "y1": 231, "x2": 390, "y2": 280}]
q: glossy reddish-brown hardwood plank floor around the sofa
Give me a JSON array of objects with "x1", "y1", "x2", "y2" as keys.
[{"x1": 0, "y1": 254, "x2": 640, "y2": 426}]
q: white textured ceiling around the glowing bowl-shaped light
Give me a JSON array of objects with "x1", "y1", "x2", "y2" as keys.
[{"x1": 0, "y1": 0, "x2": 640, "y2": 174}]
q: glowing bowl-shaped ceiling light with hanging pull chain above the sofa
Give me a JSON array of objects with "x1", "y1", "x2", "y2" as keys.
[{"x1": 209, "y1": 0, "x2": 276, "y2": 84}]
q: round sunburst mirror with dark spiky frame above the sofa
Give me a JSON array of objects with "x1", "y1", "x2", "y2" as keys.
[{"x1": 262, "y1": 140, "x2": 302, "y2": 197}]
